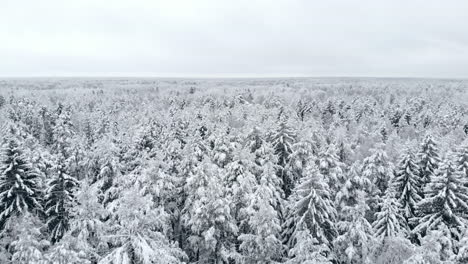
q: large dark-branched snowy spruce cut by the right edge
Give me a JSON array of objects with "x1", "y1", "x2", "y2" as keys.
[{"x1": 413, "y1": 156, "x2": 468, "y2": 242}]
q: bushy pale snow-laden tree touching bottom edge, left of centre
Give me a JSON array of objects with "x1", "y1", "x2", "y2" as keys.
[{"x1": 98, "y1": 188, "x2": 185, "y2": 264}]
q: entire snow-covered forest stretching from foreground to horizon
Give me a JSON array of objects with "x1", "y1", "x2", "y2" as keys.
[{"x1": 0, "y1": 78, "x2": 468, "y2": 264}]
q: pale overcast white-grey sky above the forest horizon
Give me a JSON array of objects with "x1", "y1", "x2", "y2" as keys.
[{"x1": 0, "y1": 0, "x2": 468, "y2": 78}]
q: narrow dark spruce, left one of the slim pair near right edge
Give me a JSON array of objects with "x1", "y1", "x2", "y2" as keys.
[{"x1": 392, "y1": 150, "x2": 421, "y2": 221}]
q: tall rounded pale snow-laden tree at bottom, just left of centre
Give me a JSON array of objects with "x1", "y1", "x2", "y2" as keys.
[{"x1": 184, "y1": 162, "x2": 238, "y2": 263}]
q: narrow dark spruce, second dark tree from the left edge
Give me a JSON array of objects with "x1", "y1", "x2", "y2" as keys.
[{"x1": 45, "y1": 158, "x2": 79, "y2": 243}]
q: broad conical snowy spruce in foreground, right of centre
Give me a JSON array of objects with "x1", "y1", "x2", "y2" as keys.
[{"x1": 289, "y1": 166, "x2": 336, "y2": 250}]
